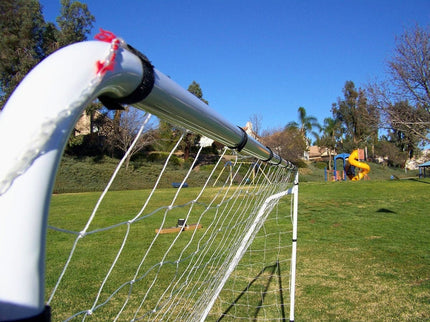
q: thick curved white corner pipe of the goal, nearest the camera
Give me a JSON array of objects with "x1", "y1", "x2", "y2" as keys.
[{"x1": 0, "y1": 41, "x2": 142, "y2": 321}]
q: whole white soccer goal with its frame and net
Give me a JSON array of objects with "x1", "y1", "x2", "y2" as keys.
[{"x1": 0, "y1": 32, "x2": 298, "y2": 321}]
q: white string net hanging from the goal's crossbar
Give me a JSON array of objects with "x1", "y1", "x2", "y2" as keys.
[{"x1": 47, "y1": 117, "x2": 295, "y2": 321}]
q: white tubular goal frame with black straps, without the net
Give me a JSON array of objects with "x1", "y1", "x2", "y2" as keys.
[{"x1": 0, "y1": 31, "x2": 298, "y2": 321}]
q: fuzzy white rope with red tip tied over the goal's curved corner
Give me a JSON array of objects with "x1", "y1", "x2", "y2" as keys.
[{"x1": 0, "y1": 32, "x2": 124, "y2": 196}]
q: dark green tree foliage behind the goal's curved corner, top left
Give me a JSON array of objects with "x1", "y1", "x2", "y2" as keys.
[{"x1": 0, "y1": 0, "x2": 95, "y2": 109}]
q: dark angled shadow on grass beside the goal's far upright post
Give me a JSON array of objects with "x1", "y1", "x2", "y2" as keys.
[{"x1": 217, "y1": 261, "x2": 286, "y2": 321}]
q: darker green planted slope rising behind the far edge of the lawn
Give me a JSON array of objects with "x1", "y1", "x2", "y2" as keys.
[{"x1": 54, "y1": 156, "x2": 418, "y2": 193}]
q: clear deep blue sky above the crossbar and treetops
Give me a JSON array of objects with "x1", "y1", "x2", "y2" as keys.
[{"x1": 40, "y1": 0, "x2": 430, "y2": 133}]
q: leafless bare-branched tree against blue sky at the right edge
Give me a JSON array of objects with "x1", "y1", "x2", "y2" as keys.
[{"x1": 368, "y1": 26, "x2": 430, "y2": 143}]
